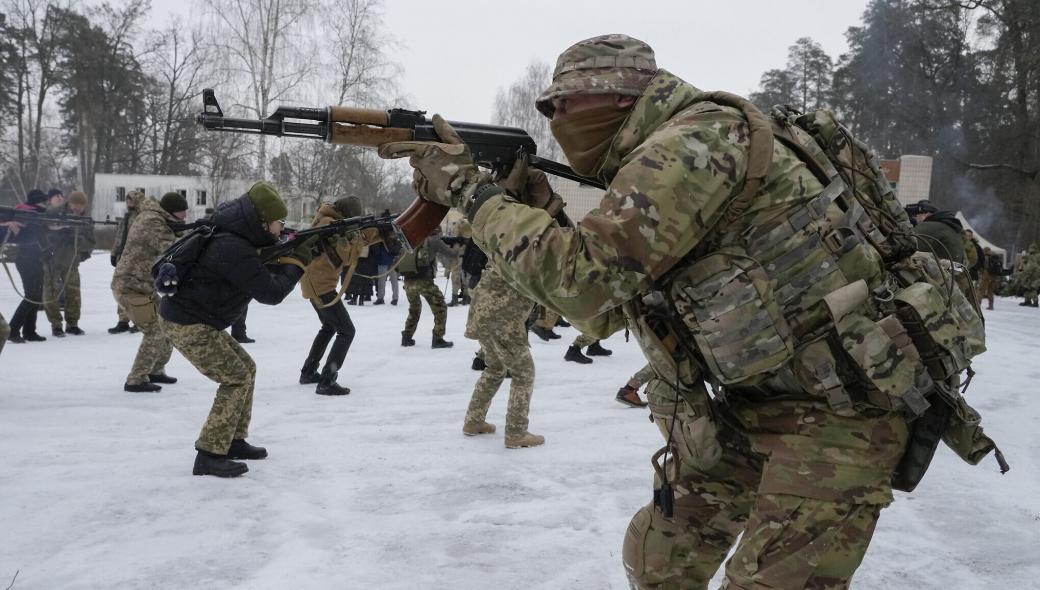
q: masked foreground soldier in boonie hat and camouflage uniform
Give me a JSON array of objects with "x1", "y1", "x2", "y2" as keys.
[{"x1": 380, "y1": 35, "x2": 973, "y2": 590}]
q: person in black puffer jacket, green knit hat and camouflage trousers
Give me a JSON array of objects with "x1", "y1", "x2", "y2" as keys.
[{"x1": 159, "y1": 182, "x2": 311, "y2": 478}]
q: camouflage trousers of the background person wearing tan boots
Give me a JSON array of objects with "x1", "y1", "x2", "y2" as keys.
[{"x1": 466, "y1": 324, "x2": 535, "y2": 436}]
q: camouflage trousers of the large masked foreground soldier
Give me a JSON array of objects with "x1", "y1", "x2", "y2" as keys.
[{"x1": 622, "y1": 395, "x2": 907, "y2": 590}]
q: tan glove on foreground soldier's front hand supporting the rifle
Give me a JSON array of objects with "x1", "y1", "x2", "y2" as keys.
[{"x1": 379, "y1": 114, "x2": 487, "y2": 207}]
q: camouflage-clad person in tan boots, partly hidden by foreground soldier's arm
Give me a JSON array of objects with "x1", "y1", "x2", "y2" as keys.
[{"x1": 462, "y1": 266, "x2": 545, "y2": 448}]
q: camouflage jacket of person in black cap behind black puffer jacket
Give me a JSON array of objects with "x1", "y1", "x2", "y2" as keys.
[{"x1": 112, "y1": 197, "x2": 180, "y2": 296}]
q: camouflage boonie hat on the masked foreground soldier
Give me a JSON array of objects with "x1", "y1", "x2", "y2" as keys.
[{"x1": 535, "y1": 34, "x2": 657, "y2": 119}]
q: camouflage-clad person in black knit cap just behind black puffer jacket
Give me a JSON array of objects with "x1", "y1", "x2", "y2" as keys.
[{"x1": 112, "y1": 193, "x2": 188, "y2": 392}]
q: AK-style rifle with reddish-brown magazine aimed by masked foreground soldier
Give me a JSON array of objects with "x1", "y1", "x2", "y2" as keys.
[{"x1": 196, "y1": 88, "x2": 603, "y2": 248}]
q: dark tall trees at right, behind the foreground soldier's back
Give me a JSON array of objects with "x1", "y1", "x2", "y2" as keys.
[{"x1": 751, "y1": 0, "x2": 1040, "y2": 250}]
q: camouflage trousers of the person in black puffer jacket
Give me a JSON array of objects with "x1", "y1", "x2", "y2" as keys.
[{"x1": 162, "y1": 320, "x2": 257, "y2": 455}]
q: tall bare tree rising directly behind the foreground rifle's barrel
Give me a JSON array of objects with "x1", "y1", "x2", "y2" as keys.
[{"x1": 205, "y1": 0, "x2": 317, "y2": 178}]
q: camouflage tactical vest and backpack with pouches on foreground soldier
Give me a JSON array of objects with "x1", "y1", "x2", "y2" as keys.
[{"x1": 660, "y1": 93, "x2": 1006, "y2": 490}]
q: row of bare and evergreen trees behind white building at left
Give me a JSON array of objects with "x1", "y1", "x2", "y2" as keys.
[{"x1": 0, "y1": 0, "x2": 411, "y2": 217}]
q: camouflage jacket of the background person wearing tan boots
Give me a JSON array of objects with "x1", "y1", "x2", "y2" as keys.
[{"x1": 466, "y1": 266, "x2": 535, "y2": 340}]
